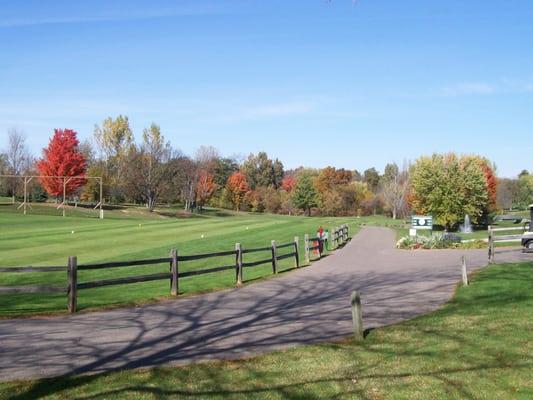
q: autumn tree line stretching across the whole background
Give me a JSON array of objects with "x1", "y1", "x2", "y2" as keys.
[{"x1": 0, "y1": 115, "x2": 533, "y2": 229}]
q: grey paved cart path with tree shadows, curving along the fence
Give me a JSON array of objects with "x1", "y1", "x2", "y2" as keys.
[{"x1": 0, "y1": 228, "x2": 531, "y2": 381}]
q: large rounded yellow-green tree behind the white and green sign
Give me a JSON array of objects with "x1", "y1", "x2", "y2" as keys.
[{"x1": 410, "y1": 154, "x2": 489, "y2": 229}]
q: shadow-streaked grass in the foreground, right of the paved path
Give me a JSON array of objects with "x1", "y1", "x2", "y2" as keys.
[{"x1": 0, "y1": 263, "x2": 533, "y2": 400}]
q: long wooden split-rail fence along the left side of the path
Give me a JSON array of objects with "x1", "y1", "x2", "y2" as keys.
[{"x1": 0, "y1": 225, "x2": 349, "y2": 313}]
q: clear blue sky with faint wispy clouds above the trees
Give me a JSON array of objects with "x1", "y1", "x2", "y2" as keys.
[{"x1": 0, "y1": 0, "x2": 533, "y2": 176}]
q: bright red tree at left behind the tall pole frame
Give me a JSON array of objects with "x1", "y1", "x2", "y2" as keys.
[{"x1": 37, "y1": 129, "x2": 87, "y2": 196}]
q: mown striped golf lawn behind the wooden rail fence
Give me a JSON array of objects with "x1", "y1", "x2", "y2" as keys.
[{"x1": 0, "y1": 205, "x2": 402, "y2": 317}]
